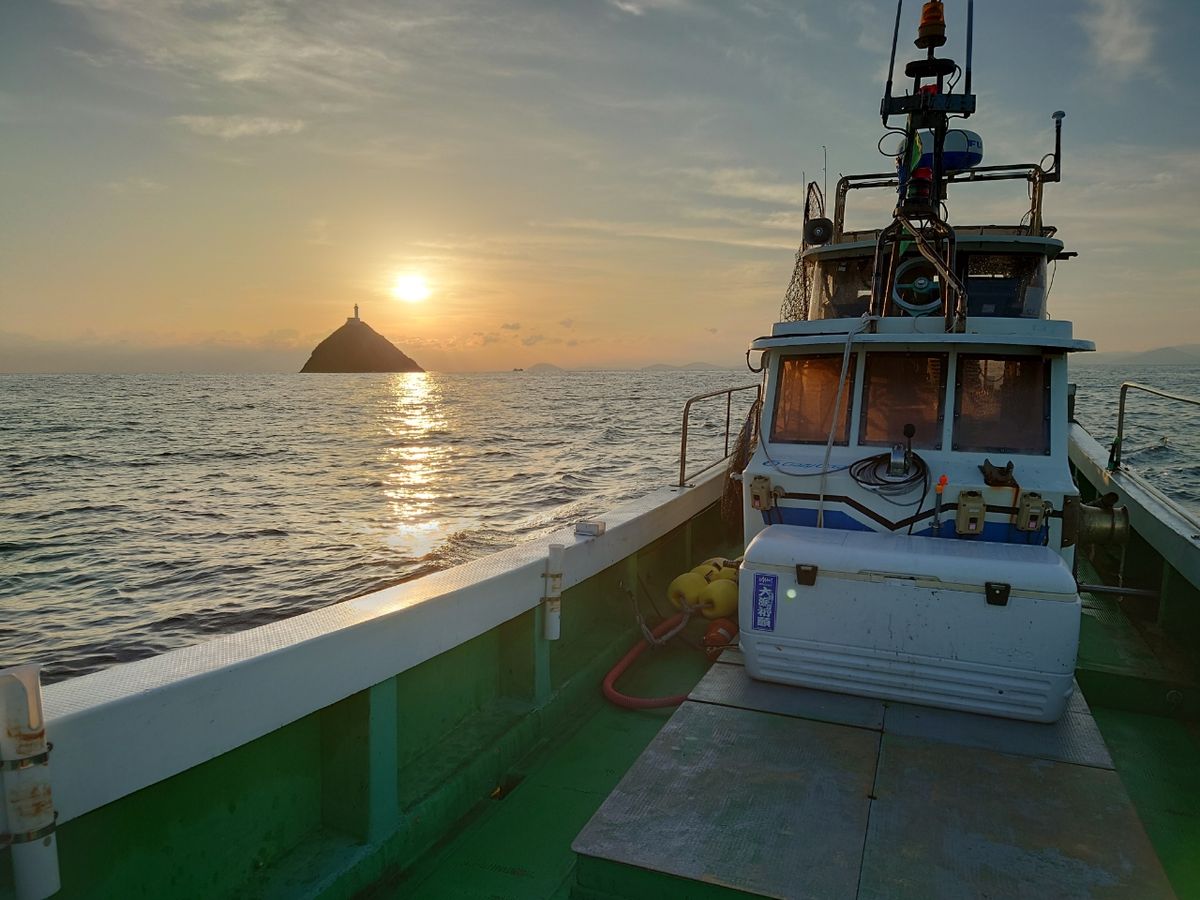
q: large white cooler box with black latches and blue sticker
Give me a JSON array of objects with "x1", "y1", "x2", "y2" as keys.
[{"x1": 738, "y1": 524, "x2": 1080, "y2": 722}]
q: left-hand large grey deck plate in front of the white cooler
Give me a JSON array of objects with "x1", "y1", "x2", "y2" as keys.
[{"x1": 572, "y1": 702, "x2": 880, "y2": 900}]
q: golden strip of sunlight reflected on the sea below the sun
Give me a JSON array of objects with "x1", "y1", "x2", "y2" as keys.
[{"x1": 379, "y1": 372, "x2": 449, "y2": 556}]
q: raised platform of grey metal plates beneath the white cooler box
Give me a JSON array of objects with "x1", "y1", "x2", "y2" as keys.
[{"x1": 574, "y1": 658, "x2": 1175, "y2": 900}]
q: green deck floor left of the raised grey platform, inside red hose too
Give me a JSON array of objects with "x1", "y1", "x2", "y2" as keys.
[{"x1": 368, "y1": 641, "x2": 708, "y2": 900}]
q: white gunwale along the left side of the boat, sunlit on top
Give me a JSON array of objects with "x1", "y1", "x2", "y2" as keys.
[{"x1": 44, "y1": 469, "x2": 725, "y2": 823}]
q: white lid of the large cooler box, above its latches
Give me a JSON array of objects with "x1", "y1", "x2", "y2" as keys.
[{"x1": 742, "y1": 524, "x2": 1078, "y2": 600}]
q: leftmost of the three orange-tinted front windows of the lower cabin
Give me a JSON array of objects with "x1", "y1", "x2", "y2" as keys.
[{"x1": 770, "y1": 353, "x2": 857, "y2": 444}]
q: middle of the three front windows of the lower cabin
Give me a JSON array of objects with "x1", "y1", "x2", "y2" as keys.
[{"x1": 858, "y1": 353, "x2": 949, "y2": 450}]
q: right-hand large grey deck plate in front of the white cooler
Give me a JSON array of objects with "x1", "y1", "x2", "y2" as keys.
[{"x1": 858, "y1": 734, "x2": 1175, "y2": 900}]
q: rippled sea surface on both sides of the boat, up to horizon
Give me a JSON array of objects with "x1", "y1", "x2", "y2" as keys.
[{"x1": 0, "y1": 366, "x2": 1200, "y2": 683}]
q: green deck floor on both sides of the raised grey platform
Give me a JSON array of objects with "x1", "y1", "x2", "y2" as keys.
[{"x1": 367, "y1": 592, "x2": 1200, "y2": 900}]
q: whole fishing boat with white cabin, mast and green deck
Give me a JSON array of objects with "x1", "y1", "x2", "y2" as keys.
[{"x1": 0, "y1": 0, "x2": 1200, "y2": 900}]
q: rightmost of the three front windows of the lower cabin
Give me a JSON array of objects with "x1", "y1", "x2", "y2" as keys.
[{"x1": 954, "y1": 355, "x2": 1050, "y2": 454}]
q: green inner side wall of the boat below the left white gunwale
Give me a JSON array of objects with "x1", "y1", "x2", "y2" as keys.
[{"x1": 0, "y1": 496, "x2": 737, "y2": 900}]
